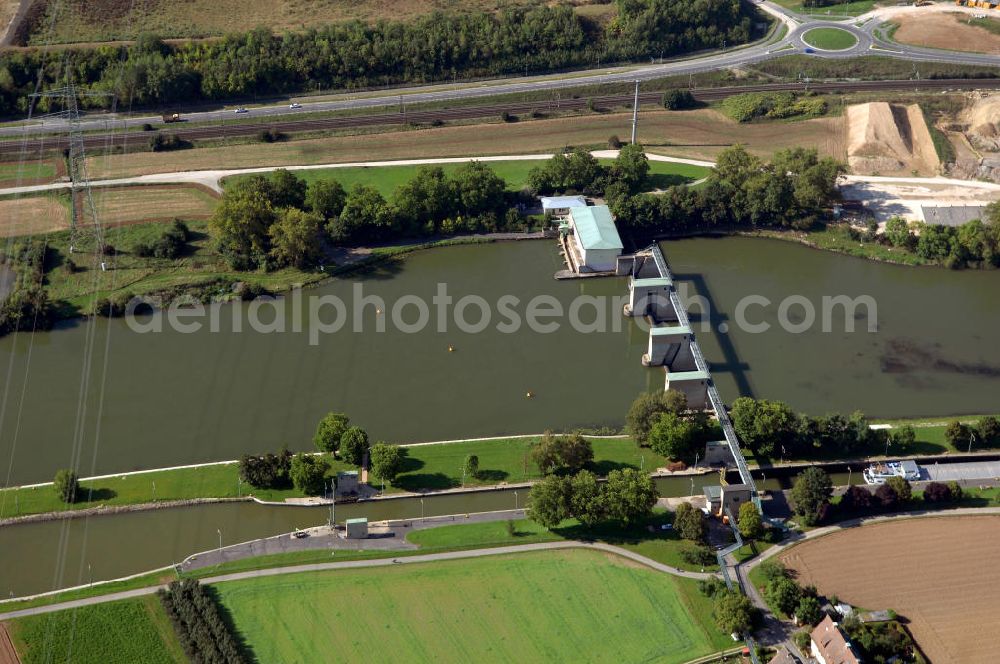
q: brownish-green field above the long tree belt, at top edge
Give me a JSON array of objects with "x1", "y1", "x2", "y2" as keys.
[{"x1": 21, "y1": 0, "x2": 589, "y2": 43}]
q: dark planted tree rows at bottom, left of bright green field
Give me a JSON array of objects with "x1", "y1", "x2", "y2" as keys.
[{"x1": 157, "y1": 579, "x2": 246, "y2": 664}]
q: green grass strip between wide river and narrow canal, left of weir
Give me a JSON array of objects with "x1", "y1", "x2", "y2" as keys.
[{"x1": 0, "y1": 438, "x2": 652, "y2": 518}]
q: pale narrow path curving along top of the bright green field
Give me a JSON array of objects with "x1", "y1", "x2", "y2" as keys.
[{"x1": 0, "y1": 541, "x2": 714, "y2": 621}]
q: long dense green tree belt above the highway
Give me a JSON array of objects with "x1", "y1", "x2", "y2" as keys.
[{"x1": 0, "y1": 0, "x2": 763, "y2": 115}]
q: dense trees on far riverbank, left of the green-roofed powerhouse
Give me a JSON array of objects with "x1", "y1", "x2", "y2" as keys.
[{"x1": 210, "y1": 162, "x2": 521, "y2": 270}]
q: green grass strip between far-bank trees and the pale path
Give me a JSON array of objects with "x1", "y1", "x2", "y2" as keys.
[{"x1": 223, "y1": 159, "x2": 709, "y2": 196}]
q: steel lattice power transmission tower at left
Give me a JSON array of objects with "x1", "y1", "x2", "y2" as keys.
[{"x1": 26, "y1": 84, "x2": 117, "y2": 260}]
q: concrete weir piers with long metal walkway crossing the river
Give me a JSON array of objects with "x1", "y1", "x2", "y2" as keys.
[{"x1": 616, "y1": 244, "x2": 762, "y2": 511}]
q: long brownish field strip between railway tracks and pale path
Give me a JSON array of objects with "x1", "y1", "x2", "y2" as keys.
[{"x1": 87, "y1": 109, "x2": 847, "y2": 179}]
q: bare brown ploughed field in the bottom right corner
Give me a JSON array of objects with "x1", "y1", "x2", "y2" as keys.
[{"x1": 782, "y1": 516, "x2": 1000, "y2": 664}]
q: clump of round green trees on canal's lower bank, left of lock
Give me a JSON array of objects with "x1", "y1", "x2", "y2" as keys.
[{"x1": 529, "y1": 468, "x2": 659, "y2": 528}]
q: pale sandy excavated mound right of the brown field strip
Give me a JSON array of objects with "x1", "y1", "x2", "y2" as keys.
[{"x1": 847, "y1": 101, "x2": 941, "y2": 175}]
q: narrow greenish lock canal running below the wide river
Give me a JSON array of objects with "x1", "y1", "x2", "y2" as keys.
[{"x1": 0, "y1": 472, "x2": 844, "y2": 597}]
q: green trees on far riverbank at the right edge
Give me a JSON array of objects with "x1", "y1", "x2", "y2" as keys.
[{"x1": 880, "y1": 208, "x2": 1000, "y2": 269}]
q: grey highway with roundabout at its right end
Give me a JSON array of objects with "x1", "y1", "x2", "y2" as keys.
[{"x1": 0, "y1": 1, "x2": 1000, "y2": 143}]
